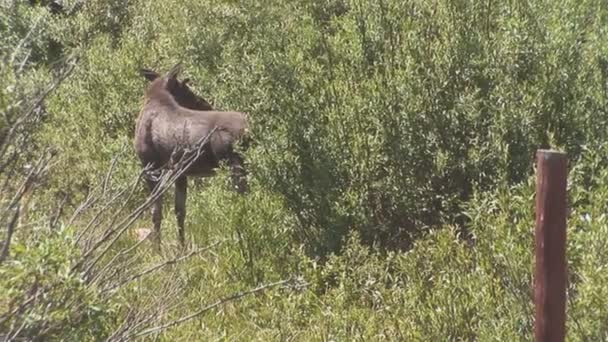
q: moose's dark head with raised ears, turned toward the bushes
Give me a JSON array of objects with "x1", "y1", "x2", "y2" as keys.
[{"x1": 139, "y1": 64, "x2": 213, "y2": 110}]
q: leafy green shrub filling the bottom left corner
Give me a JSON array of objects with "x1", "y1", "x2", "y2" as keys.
[{"x1": 0, "y1": 230, "x2": 116, "y2": 340}]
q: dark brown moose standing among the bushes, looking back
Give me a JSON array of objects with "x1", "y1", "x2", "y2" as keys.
[{"x1": 135, "y1": 64, "x2": 247, "y2": 246}]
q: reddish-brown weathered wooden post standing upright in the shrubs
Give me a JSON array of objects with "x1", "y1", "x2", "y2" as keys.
[{"x1": 534, "y1": 150, "x2": 568, "y2": 342}]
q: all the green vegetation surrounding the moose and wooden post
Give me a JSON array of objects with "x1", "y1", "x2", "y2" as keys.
[{"x1": 0, "y1": 0, "x2": 608, "y2": 341}]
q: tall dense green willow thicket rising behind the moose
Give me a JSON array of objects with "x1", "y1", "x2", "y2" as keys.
[{"x1": 39, "y1": 0, "x2": 608, "y2": 254}]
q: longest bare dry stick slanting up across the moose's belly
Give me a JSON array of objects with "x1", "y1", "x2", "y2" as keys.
[{"x1": 70, "y1": 127, "x2": 217, "y2": 277}]
